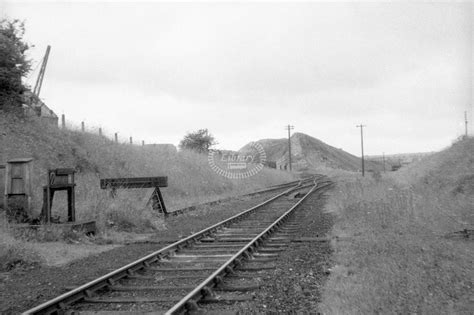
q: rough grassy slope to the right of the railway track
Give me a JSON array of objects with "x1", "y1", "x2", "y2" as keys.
[{"x1": 321, "y1": 138, "x2": 474, "y2": 314}]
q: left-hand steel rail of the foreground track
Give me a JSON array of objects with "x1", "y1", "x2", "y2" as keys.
[{"x1": 22, "y1": 181, "x2": 312, "y2": 315}]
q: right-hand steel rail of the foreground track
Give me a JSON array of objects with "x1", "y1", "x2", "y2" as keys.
[{"x1": 165, "y1": 180, "x2": 331, "y2": 315}]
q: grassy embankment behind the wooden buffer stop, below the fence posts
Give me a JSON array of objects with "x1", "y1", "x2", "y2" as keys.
[{"x1": 0, "y1": 112, "x2": 294, "y2": 268}]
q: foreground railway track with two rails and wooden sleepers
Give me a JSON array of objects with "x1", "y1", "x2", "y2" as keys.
[{"x1": 24, "y1": 177, "x2": 332, "y2": 314}]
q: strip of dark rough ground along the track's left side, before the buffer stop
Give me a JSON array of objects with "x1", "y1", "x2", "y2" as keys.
[{"x1": 0, "y1": 191, "x2": 286, "y2": 314}]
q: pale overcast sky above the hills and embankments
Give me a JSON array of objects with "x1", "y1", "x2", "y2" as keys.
[{"x1": 0, "y1": 0, "x2": 474, "y2": 155}]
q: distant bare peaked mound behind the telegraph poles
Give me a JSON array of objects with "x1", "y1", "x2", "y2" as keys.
[{"x1": 240, "y1": 133, "x2": 381, "y2": 171}]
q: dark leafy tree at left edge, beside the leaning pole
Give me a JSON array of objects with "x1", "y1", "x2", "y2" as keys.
[{"x1": 0, "y1": 19, "x2": 31, "y2": 112}]
